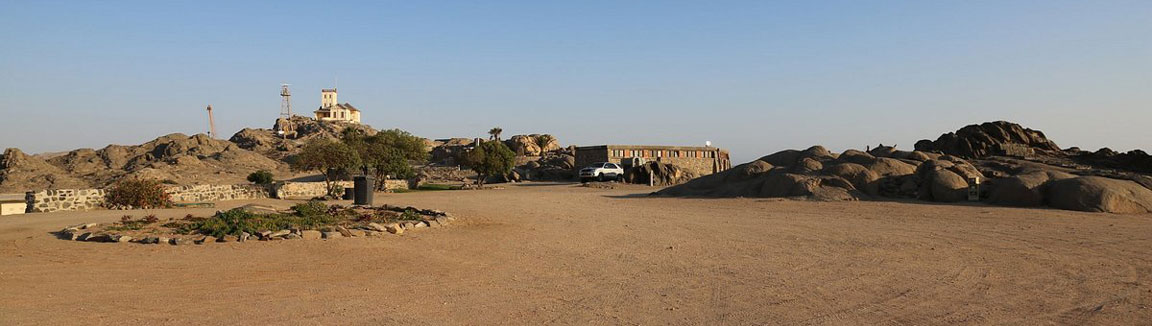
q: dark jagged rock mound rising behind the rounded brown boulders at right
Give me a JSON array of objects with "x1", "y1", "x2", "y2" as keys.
[{"x1": 916, "y1": 121, "x2": 1060, "y2": 159}]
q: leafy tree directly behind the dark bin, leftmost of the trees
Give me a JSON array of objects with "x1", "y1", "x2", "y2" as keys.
[{"x1": 291, "y1": 138, "x2": 361, "y2": 195}]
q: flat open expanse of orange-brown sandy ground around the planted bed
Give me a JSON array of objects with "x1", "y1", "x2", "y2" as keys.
[{"x1": 0, "y1": 183, "x2": 1152, "y2": 325}]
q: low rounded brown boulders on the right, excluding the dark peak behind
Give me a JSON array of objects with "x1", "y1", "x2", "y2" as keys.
[{"x1": 654, "y1": 141, "x2": 1152, "y2": 213}]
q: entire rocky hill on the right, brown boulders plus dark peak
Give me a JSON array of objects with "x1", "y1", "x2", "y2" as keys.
[{"x1": 654, "y1": 121, "x2": 1152, "y2": 213}]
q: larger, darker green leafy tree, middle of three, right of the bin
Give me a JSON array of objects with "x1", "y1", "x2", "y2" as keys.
[{"x1": 354, "y1": 129, "x2": 429, "y2": 189}]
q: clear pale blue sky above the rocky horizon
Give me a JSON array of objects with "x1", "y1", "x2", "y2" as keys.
[{"x1": 0, "y1": 0, "x2": 1152, "y2": 161}]
